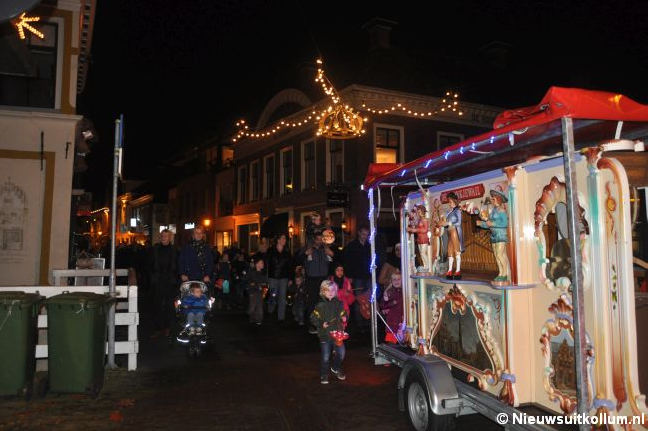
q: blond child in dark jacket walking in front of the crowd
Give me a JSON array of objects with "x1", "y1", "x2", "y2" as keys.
[{"x1": 310, "y1": 280, "x2": 348, "y2": 385}]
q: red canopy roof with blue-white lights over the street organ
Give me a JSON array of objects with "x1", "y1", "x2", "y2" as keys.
[{"x1": 364, "y1": 87, "x2": 648, "y2": 188}]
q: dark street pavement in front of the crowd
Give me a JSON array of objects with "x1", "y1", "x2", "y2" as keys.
[{"x1": 0, "y1": 296, "x2": 502, "y2": 431}]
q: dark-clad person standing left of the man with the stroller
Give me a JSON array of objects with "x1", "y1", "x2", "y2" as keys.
[{"x1": 150, "y1": 229, "x2": 178, "y2": 338}]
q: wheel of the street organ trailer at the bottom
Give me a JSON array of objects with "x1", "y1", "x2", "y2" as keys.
[{"x1": 404, "y1": 372, "x2": 456, "y2": 431}]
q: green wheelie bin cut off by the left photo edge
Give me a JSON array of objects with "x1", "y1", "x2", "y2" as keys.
[{"x1": 0, "y1": 292, "x2": 43, "y2": 398}]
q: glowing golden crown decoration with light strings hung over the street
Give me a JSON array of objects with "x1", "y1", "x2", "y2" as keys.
[{"x1": 232, "y1": 59, "x2": 463, "y2": 142}]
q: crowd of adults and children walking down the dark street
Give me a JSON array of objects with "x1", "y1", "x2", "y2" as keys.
[{"x1": 109, "y1": 214, "x2": 403, "y2": 383}]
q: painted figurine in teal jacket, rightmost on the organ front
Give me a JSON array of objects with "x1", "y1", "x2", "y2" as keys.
[{"x1": 476, "y1": 190, "x2": 510, "y2": 282}]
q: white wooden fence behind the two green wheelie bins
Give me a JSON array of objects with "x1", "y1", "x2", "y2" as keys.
[{"x1": 0, "y1": 269, "x2": 140, "y2": 370}]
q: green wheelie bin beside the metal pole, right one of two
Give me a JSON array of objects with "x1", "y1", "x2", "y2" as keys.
[{"x1": 45, "y1": 292, "x2": 113, "y2": 397}]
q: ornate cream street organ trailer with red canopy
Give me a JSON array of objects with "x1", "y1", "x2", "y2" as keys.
[{"x1": 362, "y1": 87, "x2": 648, "y2": 430}]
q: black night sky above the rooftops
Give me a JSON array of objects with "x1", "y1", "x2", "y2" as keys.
[{"x1": 78, "y1": 0, "x2": 648, "y2": 202}]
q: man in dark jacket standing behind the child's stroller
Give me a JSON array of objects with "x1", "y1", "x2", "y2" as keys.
[{"x1": 178, "y1": 226, "x2": 214, "y2": 292}]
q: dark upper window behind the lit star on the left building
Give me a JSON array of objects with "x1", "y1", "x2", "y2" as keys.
[{"x1": 0, "y1": 22, "x2": 61, "y2": 109}]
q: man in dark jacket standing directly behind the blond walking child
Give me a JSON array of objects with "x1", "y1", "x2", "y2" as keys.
[{"x1": 298, "y1": 232, "x2": 334, "y2": 334}]
